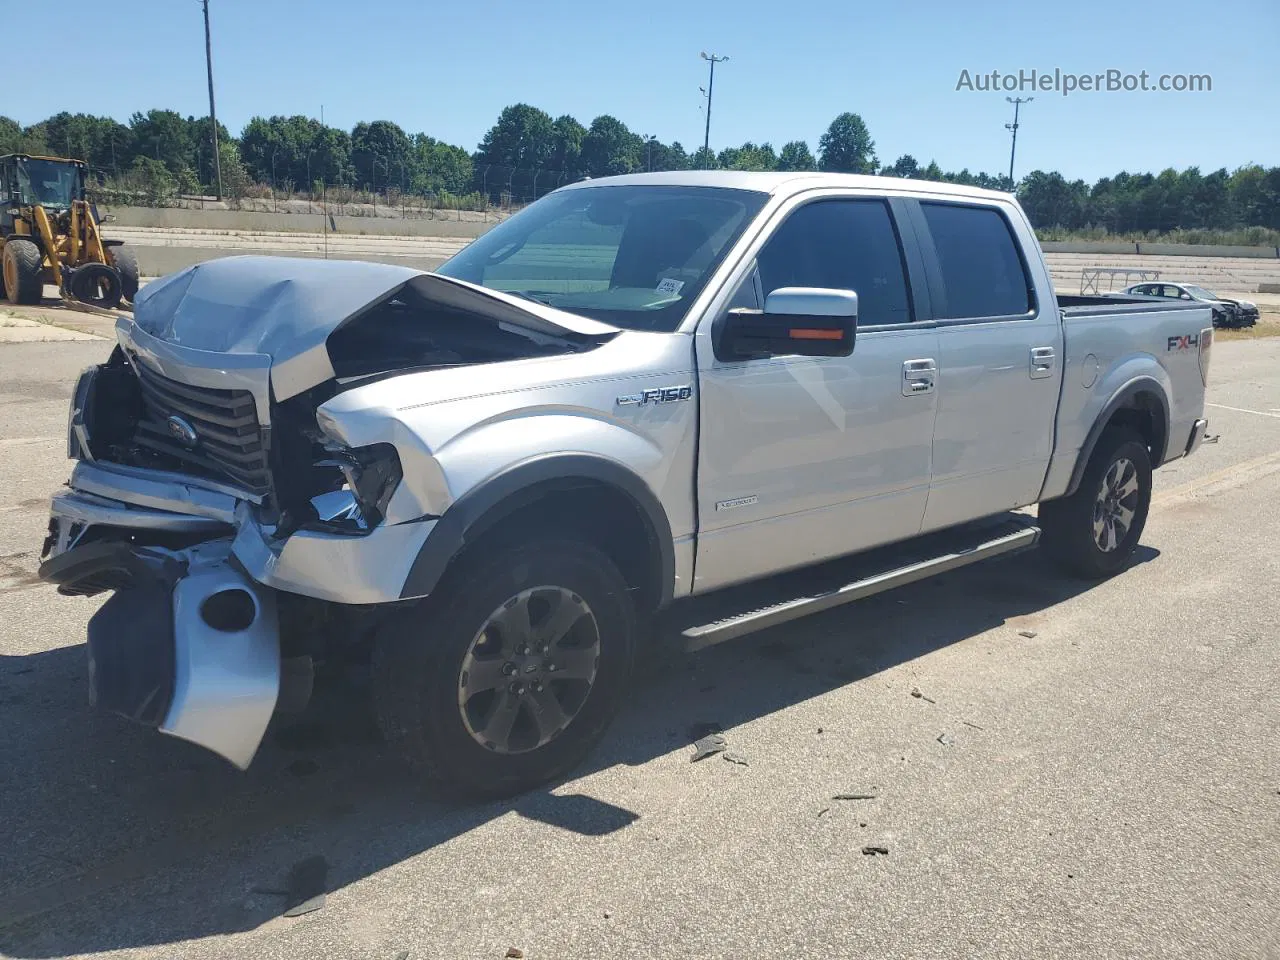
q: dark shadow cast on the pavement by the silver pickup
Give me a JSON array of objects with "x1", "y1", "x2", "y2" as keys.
[{"x1": 0, "y1": 547, "x2": 1158, "y2": 957}]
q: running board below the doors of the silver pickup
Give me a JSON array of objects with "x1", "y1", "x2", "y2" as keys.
[{"x1": 680, "y1": 517, "x2": 1041, "y2": 652}]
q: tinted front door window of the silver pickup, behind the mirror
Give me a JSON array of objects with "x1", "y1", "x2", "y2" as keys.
[{"x1": 756, "y1": 200, "x2": 911, "y2": 325}]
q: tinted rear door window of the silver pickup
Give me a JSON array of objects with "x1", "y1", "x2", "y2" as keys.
[{"x1": 920, "y1": 202, "x2": 1032, "y2": 319}]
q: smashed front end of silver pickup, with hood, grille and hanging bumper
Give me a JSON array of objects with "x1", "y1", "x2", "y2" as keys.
[{"x1": 40, "y1": 257, "x2": 616, "y2": 768}]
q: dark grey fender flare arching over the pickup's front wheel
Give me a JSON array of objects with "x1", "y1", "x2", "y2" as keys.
[{"x1": 401, "y1": 453, "x2": 676, "y2": 607}]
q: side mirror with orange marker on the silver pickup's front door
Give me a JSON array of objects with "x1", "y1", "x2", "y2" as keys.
[{"x1": 713, "y1": 287, "x2": 858, "y2": 361}]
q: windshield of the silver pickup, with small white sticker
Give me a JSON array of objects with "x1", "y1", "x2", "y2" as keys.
[{"x1": 436, "y1": 186, "x2": 768, "y2": 332}]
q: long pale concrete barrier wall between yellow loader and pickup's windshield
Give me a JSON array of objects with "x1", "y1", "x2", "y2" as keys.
[{"x1": 100, "y1": 206, "x2": 495, "y2": 239}]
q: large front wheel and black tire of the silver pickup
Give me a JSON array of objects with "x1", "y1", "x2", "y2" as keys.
[{"x1": 374, "y1": 540, "x2": 636, "y2": 799}]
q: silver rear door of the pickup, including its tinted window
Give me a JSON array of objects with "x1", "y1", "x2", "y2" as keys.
[{"x1": 914, "y1": 198, "x2": 1064, "y2": 530}]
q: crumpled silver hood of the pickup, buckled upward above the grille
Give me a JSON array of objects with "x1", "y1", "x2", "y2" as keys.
[{"x1": 120, "y1": 256, "x2": 617, "y2": 399}]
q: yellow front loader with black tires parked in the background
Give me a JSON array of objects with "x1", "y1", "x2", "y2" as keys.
[{"x1": 0, "y1": 154, "x2": 138, "y2": 308}]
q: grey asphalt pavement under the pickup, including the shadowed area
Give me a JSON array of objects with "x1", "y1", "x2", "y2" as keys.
[{"x1": 0, "y1": 339, "x2": 1280, "y2": 960}]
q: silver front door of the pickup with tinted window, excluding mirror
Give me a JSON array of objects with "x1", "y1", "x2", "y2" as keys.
[{"x1": 694, "y1": 196, "x2": 937, "y2": 593}]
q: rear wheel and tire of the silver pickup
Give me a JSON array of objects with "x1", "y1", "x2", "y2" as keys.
[{"x1": 1039, "y1": 428, "x2": 1151, "y2": 580}]
